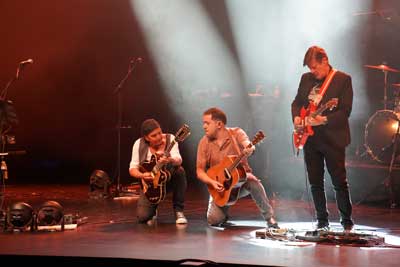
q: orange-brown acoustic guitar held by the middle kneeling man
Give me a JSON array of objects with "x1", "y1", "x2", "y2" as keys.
[{"x1": 207, "y1": 131, "x2": 265, "y2": 207}]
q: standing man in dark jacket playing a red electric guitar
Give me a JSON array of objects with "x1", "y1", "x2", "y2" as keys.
[{"x1": 292, "y1": 46, "x2": 354, "y2": 231}]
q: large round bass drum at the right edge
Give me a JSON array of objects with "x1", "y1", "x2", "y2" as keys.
[{"x1": 365, "y1": 110, "x2": 400, "y2": 164}]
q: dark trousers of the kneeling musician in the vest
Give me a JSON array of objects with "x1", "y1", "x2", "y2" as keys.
[{"x1": 136, "y1": 166, "x2": 187, "y2": 223}]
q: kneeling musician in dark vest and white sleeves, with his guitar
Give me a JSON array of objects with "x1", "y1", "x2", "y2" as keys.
[{"x1": 129, "y1": 119, "x2": 189, "y2": 224}]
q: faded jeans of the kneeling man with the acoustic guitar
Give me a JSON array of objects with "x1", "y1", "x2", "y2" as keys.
[{"x1": 207, "y1": 173, "x2": 274, "y2": 225}]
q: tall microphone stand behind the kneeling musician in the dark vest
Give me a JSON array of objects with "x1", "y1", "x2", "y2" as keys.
[{"x1": 113, "y1": 60, "x2": 135, "y2": 197}]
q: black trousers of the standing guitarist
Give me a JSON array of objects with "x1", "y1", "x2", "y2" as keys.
[{"x1": 304, "y1": 138, "x2": 354, "y2": 228}]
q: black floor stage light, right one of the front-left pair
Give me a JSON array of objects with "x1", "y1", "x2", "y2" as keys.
[{"x1": 36, "y1": 201, "x2": 64, "y2": 230}]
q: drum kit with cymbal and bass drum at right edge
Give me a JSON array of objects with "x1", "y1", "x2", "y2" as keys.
[{"x1": 364, "y1": 64, "x2": 400, "y2": 207}]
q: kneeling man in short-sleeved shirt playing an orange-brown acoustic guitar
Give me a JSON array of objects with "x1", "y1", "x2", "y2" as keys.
[{"x1": 196, "y1": 108, "x2": 279, "y2": 229}]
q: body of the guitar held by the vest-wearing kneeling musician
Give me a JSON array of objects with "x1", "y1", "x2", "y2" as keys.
[{"x1": 139, "y1": 155, "x2": 171, "y2": 204}]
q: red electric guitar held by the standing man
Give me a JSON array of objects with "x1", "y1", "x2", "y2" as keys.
[{"x1": 293, "y1": 98, "x2": 338, "y2": 155}]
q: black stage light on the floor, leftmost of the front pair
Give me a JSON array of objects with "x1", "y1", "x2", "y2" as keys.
[{"x1": 5, "y1": 202, "x2": 34, "y2": 231}]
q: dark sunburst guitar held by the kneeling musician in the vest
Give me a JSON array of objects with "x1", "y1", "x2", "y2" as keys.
[{"x1": 139, "y1": 124, "x2": 190, "y2": 204}]
